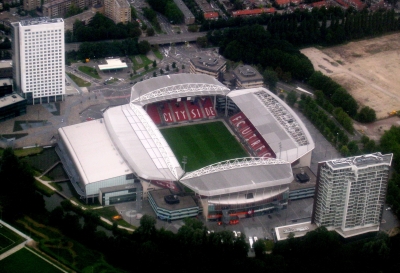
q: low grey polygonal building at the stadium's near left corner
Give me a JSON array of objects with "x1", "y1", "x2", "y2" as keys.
[{"x1": 148, "y1": 189, "x2": 200, "y2": 221}]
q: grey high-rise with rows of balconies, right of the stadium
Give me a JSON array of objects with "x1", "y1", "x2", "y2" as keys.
[{"x1": 312, "y1": 153, "x2": 393, "y2": 237}]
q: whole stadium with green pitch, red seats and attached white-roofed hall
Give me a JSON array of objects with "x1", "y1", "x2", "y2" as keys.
[{"x1": 56, "y1": 74, "x2": 314, "y2": 223}]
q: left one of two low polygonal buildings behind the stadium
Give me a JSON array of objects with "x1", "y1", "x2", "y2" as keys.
[{"x1": 190, "y1": 55, "x2": 226, "y2": 79}]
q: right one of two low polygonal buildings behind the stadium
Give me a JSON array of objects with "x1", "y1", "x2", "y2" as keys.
[{"x1": 233, "y1": 65, "x2": 264, "y2": 88}]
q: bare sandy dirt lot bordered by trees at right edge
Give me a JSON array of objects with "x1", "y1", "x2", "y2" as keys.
[{"x1": 301, "y1": 33, "x2": 400, "y2": 119}]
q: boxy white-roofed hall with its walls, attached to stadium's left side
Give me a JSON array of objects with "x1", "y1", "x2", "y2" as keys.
[{"x1": 58, "y1": 119, "x2": 135, "y2": 198}]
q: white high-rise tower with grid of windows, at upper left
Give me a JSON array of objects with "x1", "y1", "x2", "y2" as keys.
[{"x1": 12, "y1": 17, "x2": 65, "y2": 104}]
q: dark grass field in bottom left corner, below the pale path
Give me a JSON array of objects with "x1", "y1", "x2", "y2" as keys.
[{"x1": 0, "y1": 248, "x2": 61, "y2": 273}]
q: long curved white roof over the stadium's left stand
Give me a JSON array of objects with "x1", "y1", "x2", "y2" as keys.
[{"x1": 104, "y1": 104, "x2": 183, "y2": 181}]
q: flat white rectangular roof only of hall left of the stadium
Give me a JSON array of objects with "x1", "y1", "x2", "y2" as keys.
[{"x1": 58, "y1": 119, "x2": 132, "y2": 185}]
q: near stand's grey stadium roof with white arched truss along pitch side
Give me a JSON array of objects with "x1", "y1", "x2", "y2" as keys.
[{"x1": 180, "y1": 157, "x2": 293, "y2": 196}]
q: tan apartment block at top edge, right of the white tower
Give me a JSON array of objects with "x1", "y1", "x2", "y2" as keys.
[{"x1": 104, "y1": 0, "x2": 131, "y2": 24}]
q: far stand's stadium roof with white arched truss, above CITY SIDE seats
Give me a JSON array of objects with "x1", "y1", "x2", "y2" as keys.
[{"x1": 131, "y1": 73, "x2": 230, "y2": 106}]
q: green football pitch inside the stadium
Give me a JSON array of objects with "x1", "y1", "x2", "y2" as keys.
[{"x1": 161, "y1": 121, "x2": 248, "y2": 172}]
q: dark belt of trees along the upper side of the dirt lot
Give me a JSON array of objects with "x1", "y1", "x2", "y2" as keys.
[{"x1": 200, "y1": 7, "x2": 400, "y2": 47}]
